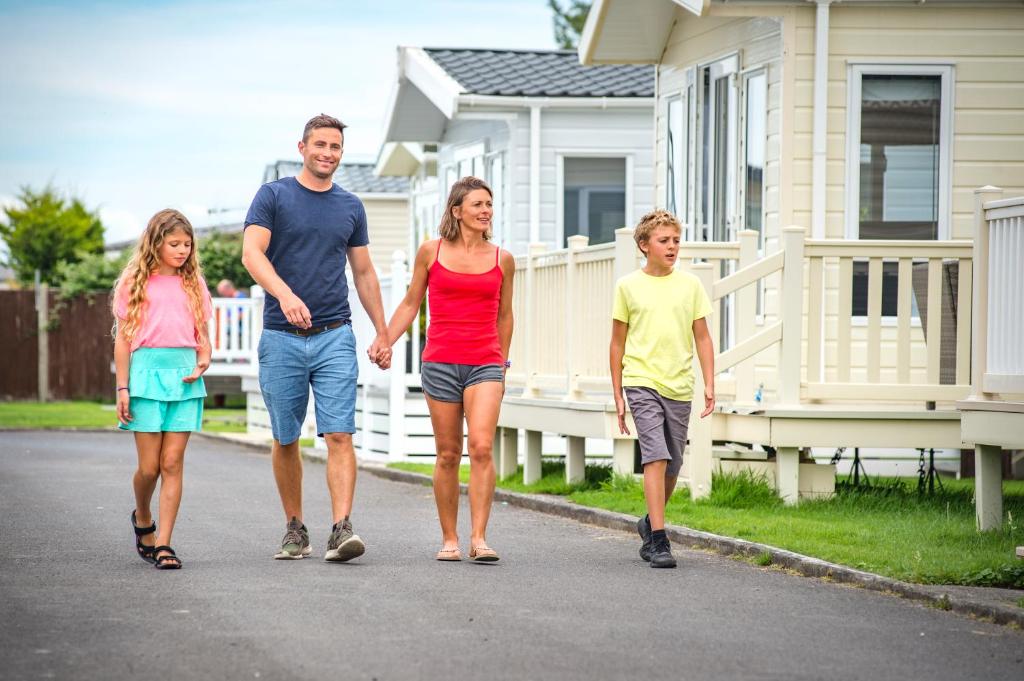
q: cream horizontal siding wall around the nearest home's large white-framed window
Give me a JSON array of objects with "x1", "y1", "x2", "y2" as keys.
[{"x1": 793, "y1": 4, "x2": 1024, "y2": 399}]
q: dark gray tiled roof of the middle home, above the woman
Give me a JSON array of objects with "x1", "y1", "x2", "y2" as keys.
[{"x1": 423, "y1": 47, "x2": 654, "y2": 97}]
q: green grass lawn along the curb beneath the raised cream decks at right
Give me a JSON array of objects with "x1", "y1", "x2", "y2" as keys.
[{"x1": 392, "y1": 462, "x2": 1024, "y2": 589}]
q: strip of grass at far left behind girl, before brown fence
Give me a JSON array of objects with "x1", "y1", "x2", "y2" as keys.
[{"x1": 0, "y1": 401, "x2": 246, "y2": 433}]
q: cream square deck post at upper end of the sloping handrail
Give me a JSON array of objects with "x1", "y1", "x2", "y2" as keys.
[{"x1": 778, "y1": 226, "x2": 804, "y2": 406}]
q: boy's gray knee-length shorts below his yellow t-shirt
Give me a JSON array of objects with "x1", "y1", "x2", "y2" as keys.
[{"x1": 626, "y1": 387, "x2": 690, "y2": 476}]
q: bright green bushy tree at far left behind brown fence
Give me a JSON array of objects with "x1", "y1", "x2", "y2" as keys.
[{"x1": 0, "y1": 185, "x2": 103, "y2": 284}]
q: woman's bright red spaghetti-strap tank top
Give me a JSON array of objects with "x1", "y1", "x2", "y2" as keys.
[{"x1": 423, "y1": 239, "x2": 505, "y2": 367}]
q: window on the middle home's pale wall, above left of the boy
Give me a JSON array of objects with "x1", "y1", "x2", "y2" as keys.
[{"x1": 562, "y1": 157, "x2": 626, "y2": 246}]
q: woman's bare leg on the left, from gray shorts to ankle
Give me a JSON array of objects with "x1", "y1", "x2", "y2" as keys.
[{"x1": 427, "y1": 397, "x2": 463, "y2": 551}]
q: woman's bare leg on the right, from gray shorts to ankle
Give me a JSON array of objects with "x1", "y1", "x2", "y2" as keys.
[{"x1": 463, "y1": 381, "x2": 505, "y2": 547}]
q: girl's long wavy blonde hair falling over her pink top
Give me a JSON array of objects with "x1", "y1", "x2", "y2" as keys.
[{"x1": 111, "y1": 208, "x2": 206, "y2": 342}]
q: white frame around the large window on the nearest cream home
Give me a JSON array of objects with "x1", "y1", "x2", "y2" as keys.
[{"x1": 844, "y1": 61, "x2": 955, "y2": 241}]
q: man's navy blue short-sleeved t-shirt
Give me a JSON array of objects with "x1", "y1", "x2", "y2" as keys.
[{"x1": 246, "y1": 177, "x2": 370, "y2": 331}]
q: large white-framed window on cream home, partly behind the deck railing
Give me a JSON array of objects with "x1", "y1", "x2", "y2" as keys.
[{"x1": 846, "y1": 65, "x2": 952, "y2": 315}]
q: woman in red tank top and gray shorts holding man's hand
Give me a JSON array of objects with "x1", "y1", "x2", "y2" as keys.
[{"x1": 388, "y1": 177, "x2": 515, "y2": 562}]
